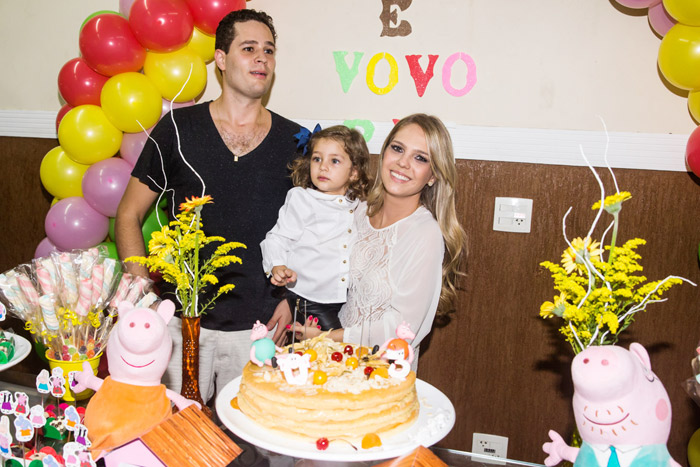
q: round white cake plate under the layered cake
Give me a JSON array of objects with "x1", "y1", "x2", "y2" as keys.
[{"x1": 216, "y1": 376, "x2": 455, "y2": 462}]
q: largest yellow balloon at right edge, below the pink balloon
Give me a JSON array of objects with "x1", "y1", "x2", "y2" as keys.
[{"x1": 659, "y1": 23, "x2": 700, "y2": 91}]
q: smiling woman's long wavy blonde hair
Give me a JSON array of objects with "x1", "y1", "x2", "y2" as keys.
[{"x1": 367, "y1": 114, "x2": 466, "y2": 315}]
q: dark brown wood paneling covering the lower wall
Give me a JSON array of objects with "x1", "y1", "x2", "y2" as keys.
[{"x1": 0, "y1": 137, "x2": 700, "y2": 465}]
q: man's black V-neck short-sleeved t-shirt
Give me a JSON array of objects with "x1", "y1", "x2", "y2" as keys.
[{"x1": 132, "y1": 102, "x2": 300, "y2": 331}]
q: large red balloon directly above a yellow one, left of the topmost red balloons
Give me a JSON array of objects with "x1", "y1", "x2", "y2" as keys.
[{"x1": 78, "y1": 14, "x2": 146, "y2": 76}]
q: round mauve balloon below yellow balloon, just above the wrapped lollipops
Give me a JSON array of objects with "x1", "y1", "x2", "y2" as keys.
[{"x1": 44, "y1": 196, "x2": 109, "y2": 251}]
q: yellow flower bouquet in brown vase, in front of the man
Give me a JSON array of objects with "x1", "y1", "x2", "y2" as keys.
[{"x1": 126, "y1": 196, "x2": 246, "y2": 318}]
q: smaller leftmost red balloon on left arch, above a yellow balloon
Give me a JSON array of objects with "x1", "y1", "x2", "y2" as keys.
[{"x1": 58, "y1": 58, "x2": 109, "y2": 107}]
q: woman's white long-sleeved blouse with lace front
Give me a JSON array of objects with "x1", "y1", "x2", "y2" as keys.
[{"x1": 339, "y1": 202, "x2": 445, "y2": 358}]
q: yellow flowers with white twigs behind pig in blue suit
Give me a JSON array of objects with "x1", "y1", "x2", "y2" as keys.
[{"x1": 540, "y1": 176, "x2": 695, "y2": 354}]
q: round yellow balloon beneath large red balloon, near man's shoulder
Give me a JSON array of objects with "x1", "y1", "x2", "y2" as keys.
[{"x1": 100, "y1": 71, "x2": 163, "y2": 133}]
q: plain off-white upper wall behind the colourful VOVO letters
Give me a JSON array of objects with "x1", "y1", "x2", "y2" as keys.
[{"x1": 0, "y1": 0, "x2": 696, "y2": 169}]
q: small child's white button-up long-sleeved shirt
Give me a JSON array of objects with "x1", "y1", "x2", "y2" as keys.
[{"x1": 260, "y1": 187, "x2": 358, "y2": 303}]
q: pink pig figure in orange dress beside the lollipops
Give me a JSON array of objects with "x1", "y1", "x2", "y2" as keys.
[{"x1": 75, "y1": 300, "x2": 199, "y2": 459}]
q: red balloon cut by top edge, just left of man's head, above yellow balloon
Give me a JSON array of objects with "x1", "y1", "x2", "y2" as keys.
[{"x1": 129, "y1": 0, "x2": 194, "y2": 52}]
